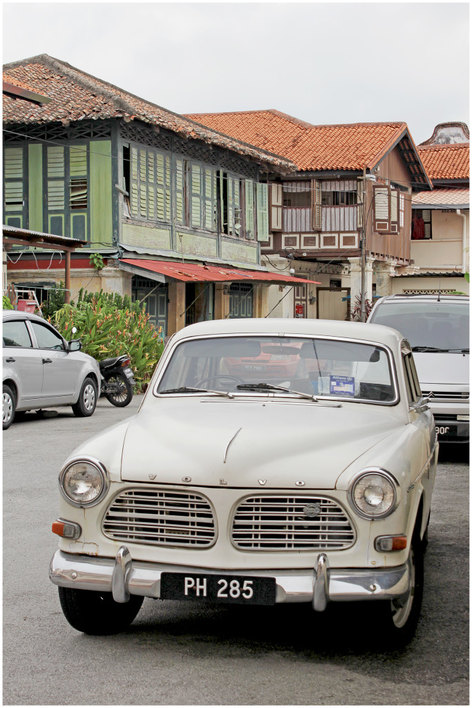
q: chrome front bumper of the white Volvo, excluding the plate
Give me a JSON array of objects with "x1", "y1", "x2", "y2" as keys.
[{"x1": 49, "y1": 546, "x2": 410, "y2": 612}]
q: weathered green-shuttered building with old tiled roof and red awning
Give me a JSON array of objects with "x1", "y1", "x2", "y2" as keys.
[{"x1": 3, "y1": 55, "x2": 318, "y2": 334}]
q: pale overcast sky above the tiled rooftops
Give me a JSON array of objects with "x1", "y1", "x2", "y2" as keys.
[{"x1": 2, "y1": 1, "x2": 469, "y2": 144}]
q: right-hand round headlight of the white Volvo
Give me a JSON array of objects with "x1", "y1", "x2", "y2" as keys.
[{"x1": 350, "y1": 470, "x2": 397, "y2": 519}]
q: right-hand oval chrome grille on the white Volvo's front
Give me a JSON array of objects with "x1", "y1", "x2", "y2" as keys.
[{"x1": 232, "y1": 495, "x2": 355, "y2": 551}]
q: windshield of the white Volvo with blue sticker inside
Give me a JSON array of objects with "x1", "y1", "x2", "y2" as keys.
[{"x1": 157, "y1": 336, "x2": 396, "y2": 402}]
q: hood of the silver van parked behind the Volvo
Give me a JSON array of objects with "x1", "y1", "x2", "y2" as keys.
[{"x1": 414, "y1": 352, "x2": 469, "y2": 391}]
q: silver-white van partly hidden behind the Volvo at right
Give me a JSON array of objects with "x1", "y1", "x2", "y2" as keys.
[{"x1": 367, "y1": 293, "x2": 469, "y2": 443}]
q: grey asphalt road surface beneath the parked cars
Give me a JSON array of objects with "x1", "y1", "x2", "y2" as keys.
[{"x1": 3, "y1": 397, "x2": 469, "y2": 705}]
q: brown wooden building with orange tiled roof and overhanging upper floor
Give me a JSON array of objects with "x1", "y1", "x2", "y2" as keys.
[{"x1": 190, "y1": 110, "x2": 431, "y2": 319}]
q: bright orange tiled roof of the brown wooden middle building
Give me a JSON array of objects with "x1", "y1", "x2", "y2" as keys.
[{"x1": 187, "y1": 109, "x2": 408, "y2": 171}]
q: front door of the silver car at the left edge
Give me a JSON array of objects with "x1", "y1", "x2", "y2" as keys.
[{"x1": 29, "y1": 322, "x2": 82, "y2": 405}]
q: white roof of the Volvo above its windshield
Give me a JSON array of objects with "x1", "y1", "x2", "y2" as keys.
[{"x1": 173, "y1": 317, "x2": 403, "y2": 348}]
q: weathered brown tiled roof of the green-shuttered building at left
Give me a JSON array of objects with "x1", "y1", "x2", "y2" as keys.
[{"x1": 3, "y1": 54, "x2": 294, "y2": 171}]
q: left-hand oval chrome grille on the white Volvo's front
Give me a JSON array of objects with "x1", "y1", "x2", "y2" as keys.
[{"x1": 103, "y1": 489, "x2": 216, "y2": 548}]
